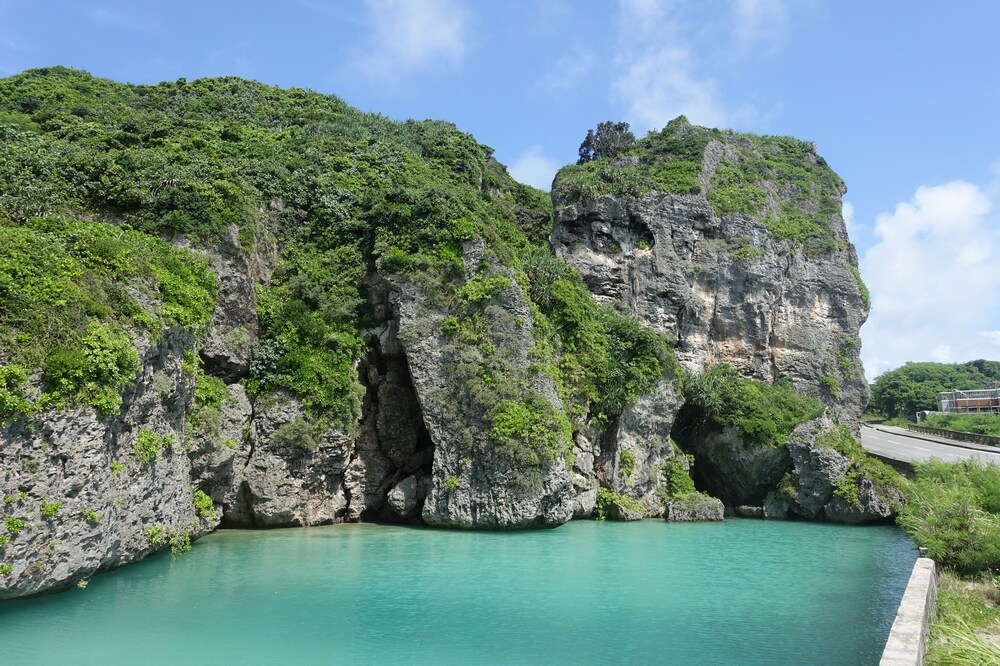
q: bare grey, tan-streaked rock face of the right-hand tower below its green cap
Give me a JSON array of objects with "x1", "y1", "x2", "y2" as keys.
[{"x1": 551, "y1": 187, "x2": 868, "y2": 429}]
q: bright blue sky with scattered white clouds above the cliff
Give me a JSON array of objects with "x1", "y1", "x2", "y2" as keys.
[{"x1": 0, "y1": 0, "x2": 1000, "y2": 377}]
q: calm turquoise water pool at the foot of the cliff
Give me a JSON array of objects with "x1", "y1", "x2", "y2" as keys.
[{"x1": 0, "y1": 520, "x2": 916, "y2": 664}]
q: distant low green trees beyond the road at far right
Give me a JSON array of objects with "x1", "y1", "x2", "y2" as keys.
[{"x1": 869, "y1": 360, "x2": 1000, "y2": 420}]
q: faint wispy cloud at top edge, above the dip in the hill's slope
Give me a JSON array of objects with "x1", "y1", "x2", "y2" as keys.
[{"x1": 358, "y1": 0, "x2": 468, "y2": 81}]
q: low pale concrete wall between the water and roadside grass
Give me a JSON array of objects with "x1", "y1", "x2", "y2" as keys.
[{"x1": 881, "y1": 557, "x2": 937, "y2": 666}]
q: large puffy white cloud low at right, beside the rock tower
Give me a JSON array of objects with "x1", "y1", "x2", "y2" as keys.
[{"x1": 861, "y1": 181, "x2": 1000, "y2": 378}]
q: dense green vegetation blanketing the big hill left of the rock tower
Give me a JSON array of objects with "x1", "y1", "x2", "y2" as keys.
[{"x1": 0, "y1": 67, "x2": 684, "y2": 466}]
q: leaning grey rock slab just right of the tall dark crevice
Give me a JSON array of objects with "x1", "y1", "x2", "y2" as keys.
[{"x1": 393, "y1": 270, "x2": 574, "y2": 529}]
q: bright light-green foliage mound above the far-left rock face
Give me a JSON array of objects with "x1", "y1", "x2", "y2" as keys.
[{"x1": 0, "y1": 215, "x2": 215, "y2": 419}]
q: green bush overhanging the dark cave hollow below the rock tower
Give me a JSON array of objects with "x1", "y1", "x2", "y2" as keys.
[{"x1": 684, "y1": 364, "x2": 823, "y2": 446}]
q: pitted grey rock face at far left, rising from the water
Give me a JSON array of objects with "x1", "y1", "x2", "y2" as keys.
[{"x1": 0, "y1": 329, "x2": 213, "y2": 598}]
